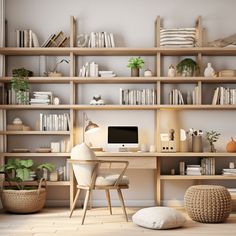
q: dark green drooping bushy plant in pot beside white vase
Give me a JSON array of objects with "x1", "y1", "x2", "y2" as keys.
[{"x1": 176, "y1": 58, "x2": 199, "y2": 77}]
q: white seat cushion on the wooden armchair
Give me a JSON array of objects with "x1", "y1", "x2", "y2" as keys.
[{"x1": 95, "y1": 174, "x2": 129, "y2": 186}]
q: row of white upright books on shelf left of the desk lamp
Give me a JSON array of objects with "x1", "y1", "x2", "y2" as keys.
[{"x1": 39, "y1": 113, "x2": 70, "y2": 131}]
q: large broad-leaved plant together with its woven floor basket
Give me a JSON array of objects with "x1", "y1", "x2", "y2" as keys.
[{"x1": 0, "y1": 159, "x2": 54, "y2": 213}]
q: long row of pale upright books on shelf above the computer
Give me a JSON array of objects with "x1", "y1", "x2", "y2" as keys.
[{"x1": 120, "y1": 88, "x2": 156, "y2": 105}]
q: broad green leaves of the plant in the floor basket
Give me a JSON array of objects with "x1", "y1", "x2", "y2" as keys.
[{"x1": 0, "y1": 159, "x2": 54, "y2": 190}]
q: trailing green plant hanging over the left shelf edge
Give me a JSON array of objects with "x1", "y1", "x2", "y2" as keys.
[{"x1": 11, "y1": 68, "x2": 33, "y2": 104}]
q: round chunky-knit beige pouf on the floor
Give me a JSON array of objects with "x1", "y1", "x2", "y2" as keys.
[{"x1": 184, "y1": 185, "x2": 231, "y2": 223}]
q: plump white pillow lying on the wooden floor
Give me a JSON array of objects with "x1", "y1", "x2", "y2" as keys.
[{"x1": 132, "y1": 207, "x2": 186, "y2": 229}]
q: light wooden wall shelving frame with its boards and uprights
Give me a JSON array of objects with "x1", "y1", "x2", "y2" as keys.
[{"x1": 0, "y1": 16, "x2": 236, "y2": 205}]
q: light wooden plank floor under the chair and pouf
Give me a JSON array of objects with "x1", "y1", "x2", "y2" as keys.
[{"x1": 0, "y1": 208, "x2": 236, "y2": 236}]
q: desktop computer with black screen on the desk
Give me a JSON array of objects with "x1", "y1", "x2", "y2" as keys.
[{"x1": 108, "y1": 126, "x2": 138, "y2": 151}]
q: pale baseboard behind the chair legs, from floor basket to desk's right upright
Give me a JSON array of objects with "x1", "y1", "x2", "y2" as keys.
[{"x1": 45, "y1": 200, "x2": 155, "y2": 207}]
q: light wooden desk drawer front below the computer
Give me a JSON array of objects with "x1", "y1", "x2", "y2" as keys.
[{"x1": 98, "y1": 157, "x2": 156, "y2": 169}]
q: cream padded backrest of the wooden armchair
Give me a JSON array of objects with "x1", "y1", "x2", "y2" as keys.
[{"x1": 71, "y1": 143, "x2": 96, "y2": 186}]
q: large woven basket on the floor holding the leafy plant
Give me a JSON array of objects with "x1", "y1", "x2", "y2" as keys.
[{"x1": 1, "y1": 181, "x2": 46, "y2": 213}]
